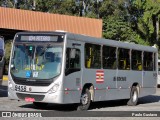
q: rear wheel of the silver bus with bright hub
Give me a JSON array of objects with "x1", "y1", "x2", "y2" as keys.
[{"x1": 127, "y1": 86, "x2": 138, "y2": 106}]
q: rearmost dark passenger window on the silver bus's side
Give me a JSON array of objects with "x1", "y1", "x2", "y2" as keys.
[{"x1": 143, "y1": 52, "x2": 153, "y2": 71}]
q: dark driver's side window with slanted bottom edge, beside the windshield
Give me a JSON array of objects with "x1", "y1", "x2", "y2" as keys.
[{"x1": 65, "y1": 48, "x2": 81, "y2": 75}]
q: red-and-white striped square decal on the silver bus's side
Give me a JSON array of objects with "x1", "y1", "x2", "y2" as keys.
[{"x1": 96, "y1": 70, "x2": 104, "y2": 83}]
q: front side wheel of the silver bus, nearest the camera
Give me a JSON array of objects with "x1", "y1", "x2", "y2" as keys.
[{"x1": 77, "y1": 88, "x2": 91, "y2": 111}]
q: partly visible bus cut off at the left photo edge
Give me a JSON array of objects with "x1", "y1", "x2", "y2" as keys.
[{"x1": 0, "y1": 36, "x2": 5, "y2": 85}]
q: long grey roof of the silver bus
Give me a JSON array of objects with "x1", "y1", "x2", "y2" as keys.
[{"x1": 17, "y1": 31, "x2": 158, "y2": 52}]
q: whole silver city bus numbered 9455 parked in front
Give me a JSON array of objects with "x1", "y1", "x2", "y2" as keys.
[{"x1": 8, "y1": 31, "x2": 158, "y2": 110}]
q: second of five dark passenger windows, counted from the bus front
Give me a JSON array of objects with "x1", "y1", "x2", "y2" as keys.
[{"x1": 103, "y1": 46, "x2": 117, "y2": 69}]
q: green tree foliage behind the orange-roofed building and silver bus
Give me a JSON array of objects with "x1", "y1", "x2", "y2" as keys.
[{"x1": 0, "y1": 0, "x2": 160, "y2": 68}]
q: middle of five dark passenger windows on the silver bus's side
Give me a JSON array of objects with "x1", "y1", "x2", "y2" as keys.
[{"x1": 118, "y1": 48, "x2": 130, "y2": 70}]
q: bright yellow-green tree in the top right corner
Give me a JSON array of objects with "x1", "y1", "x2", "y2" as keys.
[{"x1": 130, "y1": 0, "x2": 160, "y2": 45}]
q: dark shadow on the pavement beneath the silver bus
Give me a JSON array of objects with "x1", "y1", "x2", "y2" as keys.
[{"x1": 20, "y1": 95, "x2": 160, "y2": 111}]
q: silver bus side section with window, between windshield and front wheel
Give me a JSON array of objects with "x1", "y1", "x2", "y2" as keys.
[{"x1": 64, "y1": 43, "x2": 81, "y2": 103}]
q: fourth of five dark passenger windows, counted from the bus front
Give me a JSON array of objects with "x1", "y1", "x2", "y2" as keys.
[{"x1": 131, "y1": 50, "x2": 142, "y2": 70}]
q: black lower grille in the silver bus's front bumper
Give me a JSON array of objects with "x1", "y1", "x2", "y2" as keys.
[{"x1": 16, "y1": 93, "x2": 45, "y2": 101}]
